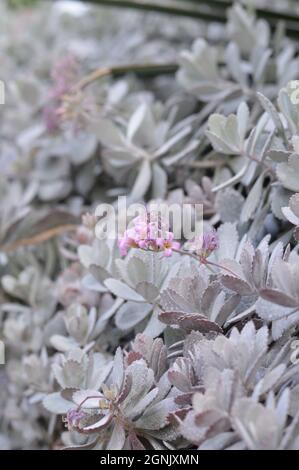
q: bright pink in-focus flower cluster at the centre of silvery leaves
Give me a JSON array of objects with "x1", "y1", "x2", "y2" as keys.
[{"x1": 118, "y1": 212, "x2": 180, "y2": 257}]
